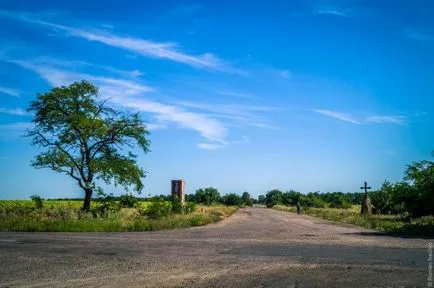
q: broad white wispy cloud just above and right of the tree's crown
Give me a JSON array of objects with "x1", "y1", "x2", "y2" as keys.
[{"x1": 6, "y1": 60, "x2": 232, "y2": 145}]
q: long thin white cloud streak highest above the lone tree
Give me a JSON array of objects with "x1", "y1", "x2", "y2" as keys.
[{"x1": 0, "y1": 11, "x2": 244, "y2": 74}]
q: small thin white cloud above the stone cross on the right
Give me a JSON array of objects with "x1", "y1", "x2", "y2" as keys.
[{"x1": 312, "y1": 109, "x2": 408, "y2": 125}]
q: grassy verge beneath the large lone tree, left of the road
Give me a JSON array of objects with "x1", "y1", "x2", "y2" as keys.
[{"x1": 0, "y1": 200, "x2": 238, "y2": 232}]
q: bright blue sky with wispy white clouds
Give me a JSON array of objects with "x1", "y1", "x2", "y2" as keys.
[{"x1": 0, "y1": 0, "x2": 434, "y2": 199}]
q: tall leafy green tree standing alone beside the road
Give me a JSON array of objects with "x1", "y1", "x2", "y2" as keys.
[{"x1": 27, "y1": 81, "x2": 150, "y2": 210}]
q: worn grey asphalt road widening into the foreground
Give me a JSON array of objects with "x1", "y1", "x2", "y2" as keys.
[{"x1": 0, "y1": 208, "x2": 431, "y2": 288}]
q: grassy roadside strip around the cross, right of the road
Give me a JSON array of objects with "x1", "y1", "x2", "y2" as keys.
[{"x1": 273, "y1": 205, "x2": 434, "y2": 237}]
